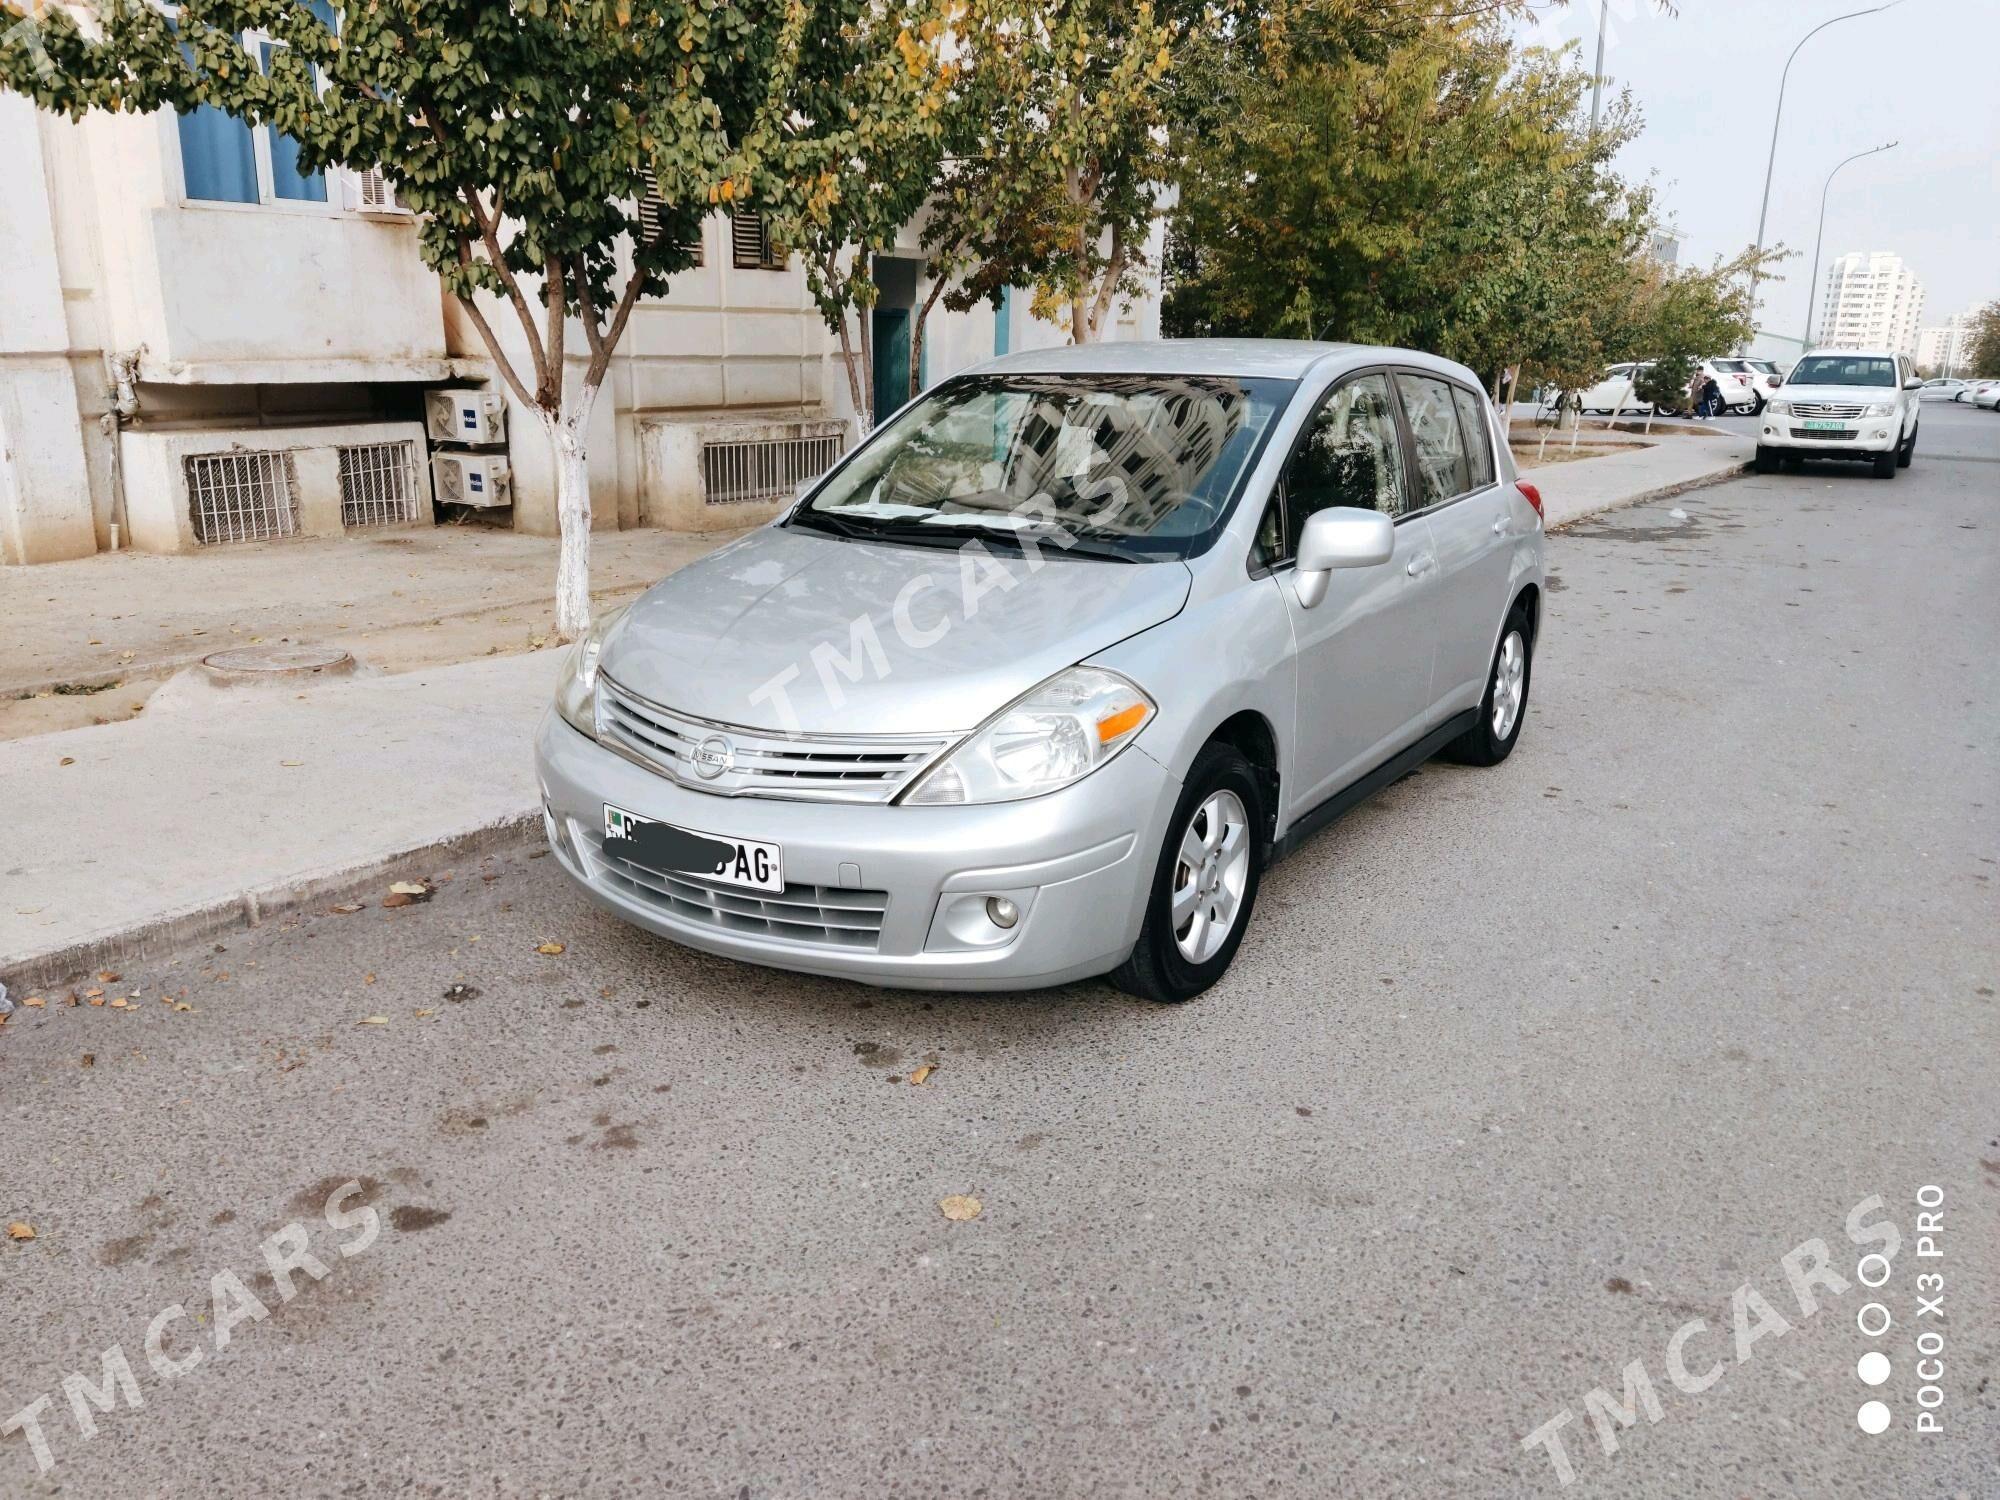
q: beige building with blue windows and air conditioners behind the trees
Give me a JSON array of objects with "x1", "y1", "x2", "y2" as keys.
[{"x1": 0, "y1": 92, "x2": 1158, "y2": 562}]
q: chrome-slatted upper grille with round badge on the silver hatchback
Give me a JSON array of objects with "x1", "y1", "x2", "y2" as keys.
[{"x1": 598, "y1": 672, "x2": 956, "y2": 802}]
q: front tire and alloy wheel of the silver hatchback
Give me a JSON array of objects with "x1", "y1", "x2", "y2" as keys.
[{"x1": 1112, "y1": 742, "x2": 1270, "y2": 1004}]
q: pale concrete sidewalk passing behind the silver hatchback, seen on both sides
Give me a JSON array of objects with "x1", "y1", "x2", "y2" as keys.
[{"x1": 0, "y1": 436, "x2": 1750, "y2": 998}]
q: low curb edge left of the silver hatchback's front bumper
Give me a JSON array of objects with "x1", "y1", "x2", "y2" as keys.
[{"x1": 0, "y1": 808, "x2": 542, "y2": 994}]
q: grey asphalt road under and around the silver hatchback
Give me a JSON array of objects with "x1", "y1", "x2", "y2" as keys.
[{"x1": 0, "y1": 394, "x2": 2000, "y2": 1500}]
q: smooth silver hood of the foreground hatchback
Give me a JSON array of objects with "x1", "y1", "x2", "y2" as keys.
[{"x1": 602, "y1": 526, "x2": 1192, "y2": 734}]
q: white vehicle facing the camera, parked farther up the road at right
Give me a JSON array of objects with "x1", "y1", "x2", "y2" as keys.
[{"x1": 1756, "y1": 350, "x2": 1924, "y2": 480}]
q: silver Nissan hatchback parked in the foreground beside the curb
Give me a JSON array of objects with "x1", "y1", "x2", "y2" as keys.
[{"x1": 536, "y1": 340, "x2": 1542, "y2": 1000}]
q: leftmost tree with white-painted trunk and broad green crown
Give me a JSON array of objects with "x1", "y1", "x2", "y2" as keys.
[{"x1": 0, "y1": 0, "x2": 818, "y2": 640}]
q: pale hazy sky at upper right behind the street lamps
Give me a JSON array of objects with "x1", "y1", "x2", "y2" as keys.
[{"x1": 1524, "y1": 0, "x2": 2000, "y2": 338}]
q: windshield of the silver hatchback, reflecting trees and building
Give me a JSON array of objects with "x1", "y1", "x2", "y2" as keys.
[{"x1": 788, "y1": 374, "x2": 1294, "y2": 562}]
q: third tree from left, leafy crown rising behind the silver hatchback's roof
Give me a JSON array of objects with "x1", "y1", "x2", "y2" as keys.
[{"x1": 912, "y1": 0, "x2": 1174, "y2": 370}]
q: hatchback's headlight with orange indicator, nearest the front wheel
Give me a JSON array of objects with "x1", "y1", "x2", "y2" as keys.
[{"x1": 904, "y1": 666, "x2": 1156, "y2": 804}]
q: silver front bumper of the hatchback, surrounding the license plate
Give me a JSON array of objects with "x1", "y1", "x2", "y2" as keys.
[{"x1": 536, "y1": 710, "x2": 1180, "y2": 990}]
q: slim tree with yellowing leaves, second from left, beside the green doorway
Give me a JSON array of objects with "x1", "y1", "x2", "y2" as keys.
[{"x1": 768, "y1": 0, "x2": 956, "y2": 434}]
